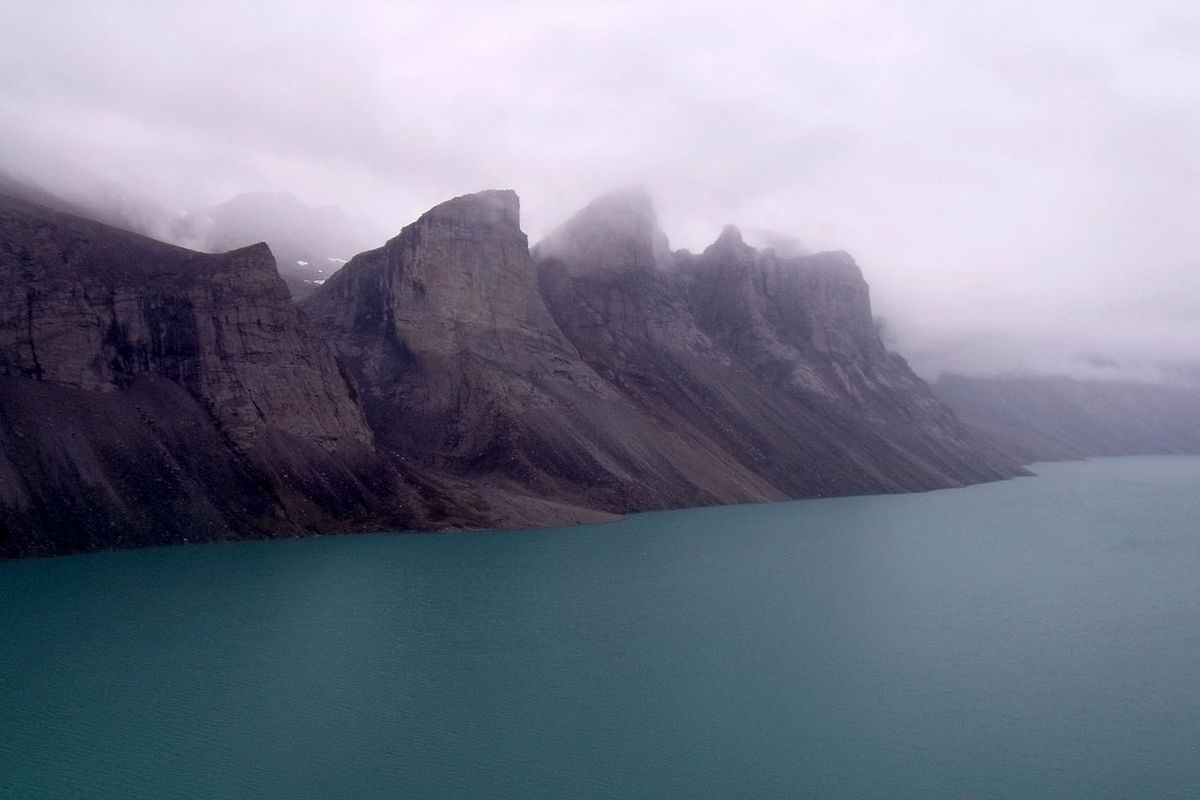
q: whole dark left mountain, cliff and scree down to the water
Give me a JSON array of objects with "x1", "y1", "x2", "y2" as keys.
[{"x1": 0, "y1": 197, "x2": 420, "y2": 554}]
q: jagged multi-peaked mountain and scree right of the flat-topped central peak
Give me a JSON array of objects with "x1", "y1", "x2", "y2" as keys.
[{"x1": 534, "y1": 187, "x2": 1012, "y2": 497}]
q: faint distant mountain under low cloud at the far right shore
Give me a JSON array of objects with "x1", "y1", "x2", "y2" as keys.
[{"x1": 934, "y1": 375, "x2": 1200, "y2": 463}]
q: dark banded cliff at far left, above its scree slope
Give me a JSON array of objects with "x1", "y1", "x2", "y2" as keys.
[{"x1": 0, "y1": 190, "x2": 371, "y2": 449}]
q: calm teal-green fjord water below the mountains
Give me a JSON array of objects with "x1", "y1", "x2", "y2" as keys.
[{"x1": 0, "y1": 457, "x2": 1200, "y2": 800}]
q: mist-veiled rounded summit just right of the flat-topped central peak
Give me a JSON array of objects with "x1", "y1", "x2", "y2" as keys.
[{"x1": 534, "y1": 187, "x2": 671, "y2": 275}]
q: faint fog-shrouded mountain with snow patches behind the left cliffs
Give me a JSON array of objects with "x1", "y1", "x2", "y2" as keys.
[{"x1": 172, "y1": 192, "x2": 371, "y2": 299}]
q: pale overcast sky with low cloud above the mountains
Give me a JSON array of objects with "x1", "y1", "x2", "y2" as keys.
[{"x1": 0, "y1": 0, "x2": 1200, "y2": 380}]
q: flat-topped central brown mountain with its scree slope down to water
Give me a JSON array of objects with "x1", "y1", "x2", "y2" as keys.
[{"x1": 305, "y1": 192, "x2": 757, "y2": 510}]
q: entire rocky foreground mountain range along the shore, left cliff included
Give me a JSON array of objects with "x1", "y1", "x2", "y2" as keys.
[{"x1": 0, "y1": 181, "x2": 1051, "y2": 557}]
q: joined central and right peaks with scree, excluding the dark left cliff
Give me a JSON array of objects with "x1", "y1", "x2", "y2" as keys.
[{"x1": 302, "y1": 191, "x2": 1018, "y2": 524}]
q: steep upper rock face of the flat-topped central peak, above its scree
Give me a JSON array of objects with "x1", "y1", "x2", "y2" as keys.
[{"x1": 305, "y1": 192, "x2": 599, "y2": 467}]
